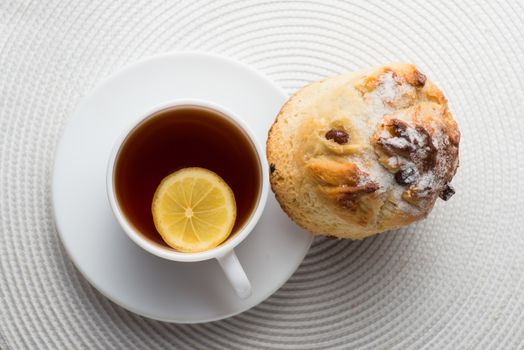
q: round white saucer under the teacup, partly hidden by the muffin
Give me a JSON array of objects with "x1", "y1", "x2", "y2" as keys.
[{"x1": 53, "y1": 53, "x2": 312, "y2": 323}]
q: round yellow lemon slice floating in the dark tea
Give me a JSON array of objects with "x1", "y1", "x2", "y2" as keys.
[{"x1": 151, "y1": 168, "x2": 237, "y2": 252}]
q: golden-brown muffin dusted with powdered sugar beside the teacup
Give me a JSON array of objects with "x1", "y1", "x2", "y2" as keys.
[{"x1": 267, "y1": 63, "x2": 460, "y2": 239}]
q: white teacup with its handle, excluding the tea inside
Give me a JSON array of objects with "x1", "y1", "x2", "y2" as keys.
[{"x1": 107, "y1": 99, "x2": 269, "y2": 298}]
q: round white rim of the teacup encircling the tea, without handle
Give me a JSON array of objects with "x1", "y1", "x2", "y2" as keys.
[{"x1": 106, "y1": 99, "x2": 269, "y2": 262}]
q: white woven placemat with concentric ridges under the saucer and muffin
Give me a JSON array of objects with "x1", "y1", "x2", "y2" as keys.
[{"x1": 0, "y1": 0, "x2": 524, "y2": 350}]
